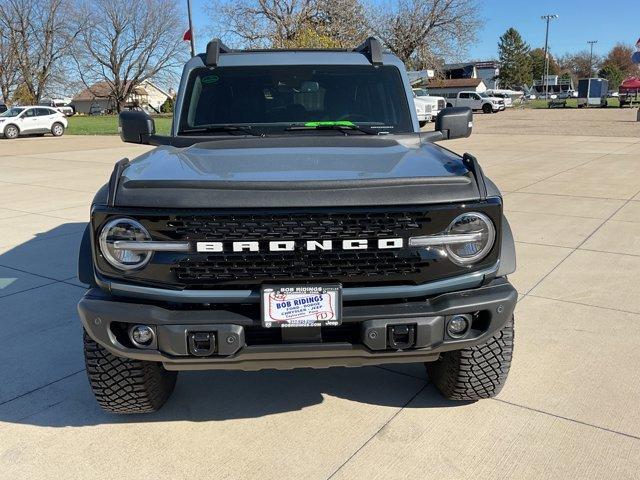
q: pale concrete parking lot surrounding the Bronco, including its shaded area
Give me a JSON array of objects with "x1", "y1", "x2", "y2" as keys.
[{"x1": 0, "y1": 116, "x2": 640, "y2": 480}]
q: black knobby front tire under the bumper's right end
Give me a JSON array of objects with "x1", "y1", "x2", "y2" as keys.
[{"x1": 426, "y1": 318, "x2": 514, "y2": 400}]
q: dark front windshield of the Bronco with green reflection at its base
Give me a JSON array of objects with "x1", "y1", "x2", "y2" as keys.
[{"x1": 179, "y1": 65, "x2": 413, "y2": 135}]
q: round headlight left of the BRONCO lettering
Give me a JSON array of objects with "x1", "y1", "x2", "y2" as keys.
[{"x1": 100, "y1": 218, "x2": 152, "y2": 270}]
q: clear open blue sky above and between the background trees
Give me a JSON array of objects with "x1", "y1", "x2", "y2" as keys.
[{"x1": 181, "y1": 0, "x2": 640, "y2": 60}]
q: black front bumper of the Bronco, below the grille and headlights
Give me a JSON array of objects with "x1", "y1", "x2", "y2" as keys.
[{"x1": 78, "y1": 279, "x2": 518, "y2": 370}]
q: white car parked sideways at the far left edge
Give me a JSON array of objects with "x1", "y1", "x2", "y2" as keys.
[{"x1": 0, "y1": 106, "x2": 69, "y2": 139}]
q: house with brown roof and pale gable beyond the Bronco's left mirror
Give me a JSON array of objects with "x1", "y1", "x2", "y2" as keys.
[{"x1": 73, "y1": 81, "x2": 173, "y2": 114}]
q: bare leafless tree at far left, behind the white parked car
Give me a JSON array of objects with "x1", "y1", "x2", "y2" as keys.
[{"x1": 0, "y1": 0, "x2": 78, "y2": 103}]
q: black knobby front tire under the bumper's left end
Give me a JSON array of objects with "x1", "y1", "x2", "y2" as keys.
[{"x1": 84, "y1": 332, "x2": 178, "y2": 414}]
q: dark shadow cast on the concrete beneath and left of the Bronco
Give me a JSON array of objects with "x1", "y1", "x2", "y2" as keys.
[{"x1": 0, "y1": 223, "x2": 465, "y2": 427}]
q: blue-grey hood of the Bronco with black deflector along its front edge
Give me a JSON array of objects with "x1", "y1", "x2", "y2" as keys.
[{"x1": 116, "y1": 134, "x2": 478, "y2": 208}]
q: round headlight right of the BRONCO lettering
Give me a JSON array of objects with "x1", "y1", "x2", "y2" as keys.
[{"x1": 446, "y1": 212, "x2": 496, "y2": 265}]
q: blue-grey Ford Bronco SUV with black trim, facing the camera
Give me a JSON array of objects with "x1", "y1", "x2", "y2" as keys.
[{"x1": 78, "y1": 39, "x2": 517, "y2": 413}]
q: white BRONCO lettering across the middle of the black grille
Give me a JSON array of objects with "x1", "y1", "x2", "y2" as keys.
[{"x1": 196, "y1": 238, "x2": 404, "y2": 253}]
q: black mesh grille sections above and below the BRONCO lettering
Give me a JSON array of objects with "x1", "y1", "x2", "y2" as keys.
[{"x1": 165, "y1": 211, "x2": 431, "y2": 285}]
